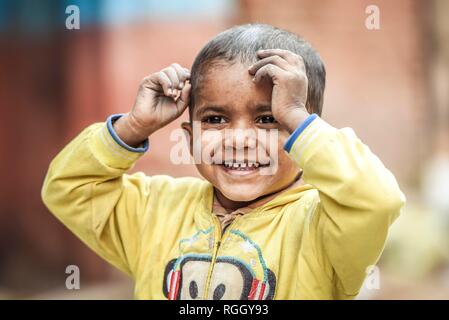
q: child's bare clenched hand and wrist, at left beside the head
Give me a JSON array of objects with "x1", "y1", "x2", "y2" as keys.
[{"x1": 114, "y1": 63, "x2": 191, "y2": 146}]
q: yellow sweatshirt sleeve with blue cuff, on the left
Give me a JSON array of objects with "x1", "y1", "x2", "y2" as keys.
[{"x1": 42, "y1": 117, "x2": 150, "y2": 275}]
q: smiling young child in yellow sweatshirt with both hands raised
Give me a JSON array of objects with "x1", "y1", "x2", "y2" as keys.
[{"x1": 42, "y1": 24, "x2": 405, "y2": 300}]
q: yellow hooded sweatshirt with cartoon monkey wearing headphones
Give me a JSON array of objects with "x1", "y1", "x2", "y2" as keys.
[{"x1": 42, "y1": 115, "x2": 405, "y2": 300}]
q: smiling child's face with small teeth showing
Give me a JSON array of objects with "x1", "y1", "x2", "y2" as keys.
[{"x1": 184, "y1": 62, "x2": 300, "y2": 201}]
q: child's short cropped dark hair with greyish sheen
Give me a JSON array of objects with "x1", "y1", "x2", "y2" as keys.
[{"x1": 189, "y1": 24, "x2": 326, "y2": 118}]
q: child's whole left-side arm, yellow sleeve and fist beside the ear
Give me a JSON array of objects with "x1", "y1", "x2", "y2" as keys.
[{"x1": 42, "y1": 64, "x2": 190, "y2": 274}]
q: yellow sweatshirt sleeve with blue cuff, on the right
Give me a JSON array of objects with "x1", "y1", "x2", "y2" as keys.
[{"x1": 284, "y1": 115, "x2": 405, "y2": 298}]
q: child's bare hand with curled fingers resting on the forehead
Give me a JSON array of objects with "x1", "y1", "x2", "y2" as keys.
[{"x1": 248, "y1": 49, "x2": 309, "y2": 132}]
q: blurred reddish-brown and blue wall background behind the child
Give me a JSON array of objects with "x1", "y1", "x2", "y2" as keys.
[{"x1": 0, "y1": 0, "x2": 449, "y2": 299}]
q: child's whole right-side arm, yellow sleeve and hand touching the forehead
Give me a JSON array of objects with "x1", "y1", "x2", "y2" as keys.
[{"x1": 248, "y1": 49, "x2": 405, "y2": 298}]
